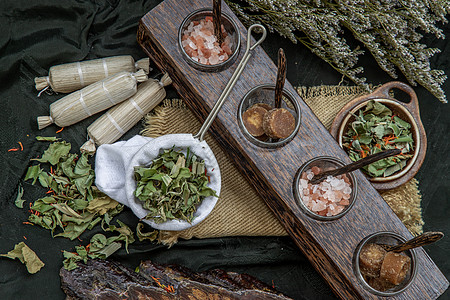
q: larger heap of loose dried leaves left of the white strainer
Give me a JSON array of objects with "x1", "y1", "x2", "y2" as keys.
[{"x1": 25, "y1": 139, "x2": 123, "y2": 240}]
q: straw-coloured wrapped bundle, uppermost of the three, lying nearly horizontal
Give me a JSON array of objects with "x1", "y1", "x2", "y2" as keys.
[{"x1": 34, "y1": 55, "x2": 150, "y2": 93}]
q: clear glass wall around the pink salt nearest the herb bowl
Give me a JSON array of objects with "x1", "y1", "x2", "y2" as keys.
[{"x1": 293, "y1": 156, "x2": 358, "y2": 221}]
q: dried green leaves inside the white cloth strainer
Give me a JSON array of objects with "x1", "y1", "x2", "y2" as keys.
[{"x1": 134, "y1": 148, "x2": 217, "y2": 223}]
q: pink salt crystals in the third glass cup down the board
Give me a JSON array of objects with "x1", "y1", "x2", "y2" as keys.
[{"x1": 299, "y1": 166, "x2": 352, "y2": 217}]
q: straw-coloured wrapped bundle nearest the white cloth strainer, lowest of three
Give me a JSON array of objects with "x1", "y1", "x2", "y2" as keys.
[{"x1": 80, "y1": 74, "x2": 172, "y2": 153}]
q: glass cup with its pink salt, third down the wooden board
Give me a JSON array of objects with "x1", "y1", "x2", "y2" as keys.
[{"x1": 294, "y1": 156, "x2": 357, "y2": 221}]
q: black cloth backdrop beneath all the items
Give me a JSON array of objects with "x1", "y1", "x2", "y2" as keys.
[{"x1": 0, "y1": 0, "x2": 450, "y2": 299}]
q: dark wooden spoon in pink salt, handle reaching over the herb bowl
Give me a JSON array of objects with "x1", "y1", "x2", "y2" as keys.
[{"x1": 310, "y1": 149, "x2": 402, "y2": 184}]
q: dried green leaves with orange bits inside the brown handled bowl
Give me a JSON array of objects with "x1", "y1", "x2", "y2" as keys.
[{"x1": 343, "y1": 100, "x2": 414, "y2": 177}]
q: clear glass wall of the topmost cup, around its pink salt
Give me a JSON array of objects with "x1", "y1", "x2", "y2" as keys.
[{"x1": 178, "y1": 8, "x2": 241, "y2": 72}]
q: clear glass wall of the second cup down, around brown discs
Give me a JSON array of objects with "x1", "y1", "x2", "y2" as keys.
[{"x1": 237, "y1": 84, "x2": 301, "y2": 148}]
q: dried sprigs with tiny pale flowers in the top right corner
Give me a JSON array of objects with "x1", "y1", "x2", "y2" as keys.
[{"x1": 227, "y1": 0, "x2": 450, "y2": 103}]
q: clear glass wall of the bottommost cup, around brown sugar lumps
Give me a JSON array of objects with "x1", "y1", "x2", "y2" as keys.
[{"x1": 352, "y1": 231, "x2": 417, "y2": 297}]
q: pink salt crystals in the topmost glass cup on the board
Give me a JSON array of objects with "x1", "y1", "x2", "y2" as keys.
[{"x1": 181, "y1": 17, "x2": 233, "y2": 65}]
